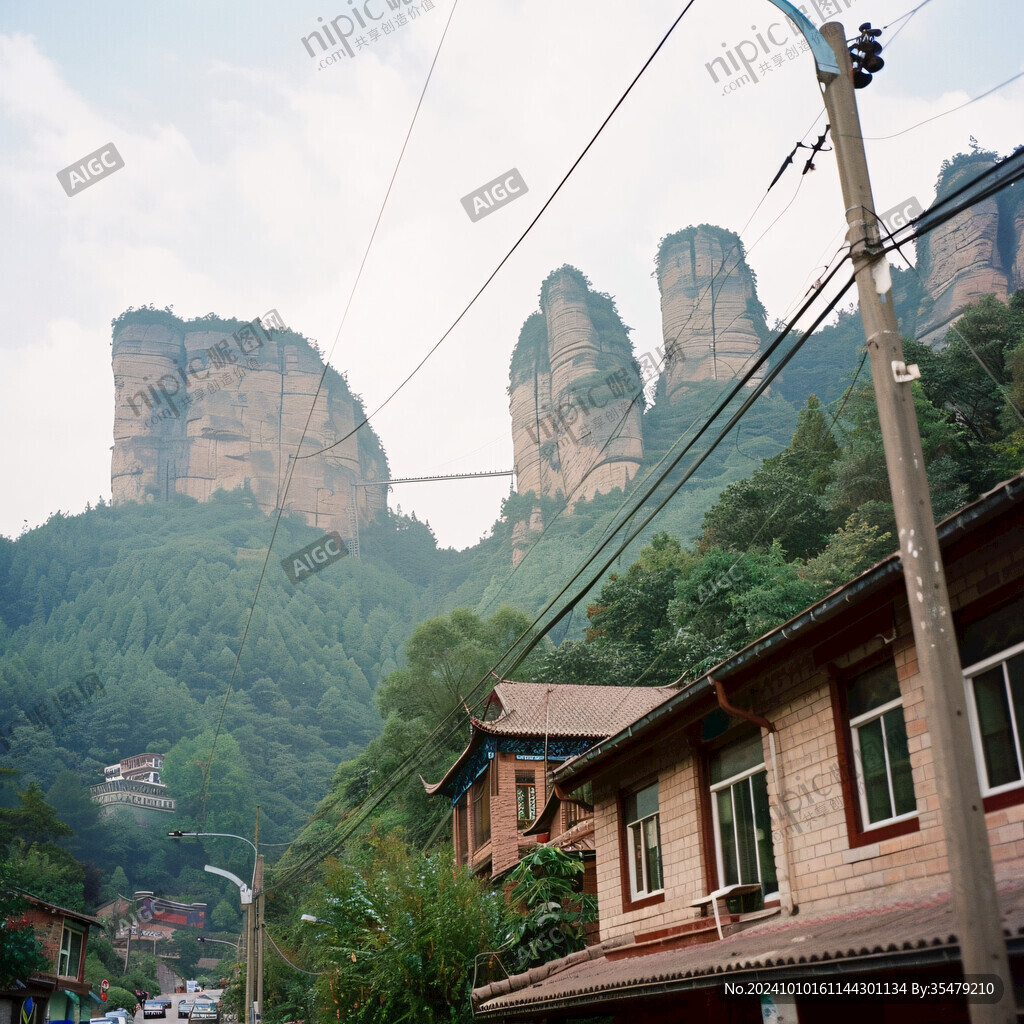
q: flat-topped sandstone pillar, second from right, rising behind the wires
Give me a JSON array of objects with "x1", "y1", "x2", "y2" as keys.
[{"x1": 656, "y1": 224, "x2": 768, "y2": 403}]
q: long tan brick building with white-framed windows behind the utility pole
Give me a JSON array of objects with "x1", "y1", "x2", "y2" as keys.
[{"x1": 473, "y1": 475, "x2": 1024, "y2": 1024}]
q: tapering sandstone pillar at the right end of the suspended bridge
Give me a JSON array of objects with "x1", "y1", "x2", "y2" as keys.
[{"x1": 509, "y1": 266, "x2": 644, "y2": 503}]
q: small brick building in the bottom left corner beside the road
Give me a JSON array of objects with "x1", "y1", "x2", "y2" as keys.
[{"x1": 0, "y1": 894, "x2": 100, "y2": 1024}]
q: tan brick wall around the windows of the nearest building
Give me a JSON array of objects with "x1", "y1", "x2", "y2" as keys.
[{"x1": 594, "y1": 516, "x2": 1024, "y2": 939}]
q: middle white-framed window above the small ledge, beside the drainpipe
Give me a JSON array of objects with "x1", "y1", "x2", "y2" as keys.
[{"x1": 708, "y1": 733, "x2": 778, "y2": 898}]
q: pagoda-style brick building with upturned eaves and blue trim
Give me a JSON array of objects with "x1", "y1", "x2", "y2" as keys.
[{"x1": 423, "y1": 680, "x2": 675, "y2": 879}]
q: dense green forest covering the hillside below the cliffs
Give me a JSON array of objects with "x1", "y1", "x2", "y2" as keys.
[{"x1": 0, "y1": 274, "x2": 1024, "y2": 983}]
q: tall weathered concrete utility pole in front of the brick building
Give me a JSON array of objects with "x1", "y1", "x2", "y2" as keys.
[{"x1": 819, "y1": 22, "x2": 1017, "y2": 1024}]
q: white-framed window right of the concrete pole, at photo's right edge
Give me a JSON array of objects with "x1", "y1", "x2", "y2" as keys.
[{"x1": 961, "y1": 598, "x2": 1024, "y2": 797}]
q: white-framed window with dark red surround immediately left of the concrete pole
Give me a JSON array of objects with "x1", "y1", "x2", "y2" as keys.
[{"x1": 846, "y1": 660, "x2": 918, "y2": 830}]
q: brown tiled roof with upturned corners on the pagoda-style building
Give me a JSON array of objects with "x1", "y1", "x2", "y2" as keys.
[{"x1": 473, "y1": 680, "x2": 676, "y2": 739}]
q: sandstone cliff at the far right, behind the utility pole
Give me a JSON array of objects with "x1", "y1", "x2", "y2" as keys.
[{"x1": 916, "y1": 151, "x2": 1024, "y2": 345}]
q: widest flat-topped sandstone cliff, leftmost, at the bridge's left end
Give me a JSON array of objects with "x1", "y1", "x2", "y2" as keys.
[{"x1": 111, "y1": 309, "x2": 389, "y2": 539}]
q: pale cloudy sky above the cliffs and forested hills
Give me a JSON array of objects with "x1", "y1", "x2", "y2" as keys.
[{"x1": 0, "y1": 0, "x2": 1024, "y2": 548}]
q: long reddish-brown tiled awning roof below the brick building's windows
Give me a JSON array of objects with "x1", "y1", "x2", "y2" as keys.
[{"x1": 473, "y1": 884, "x2": 1024, "y2": 1019}]
